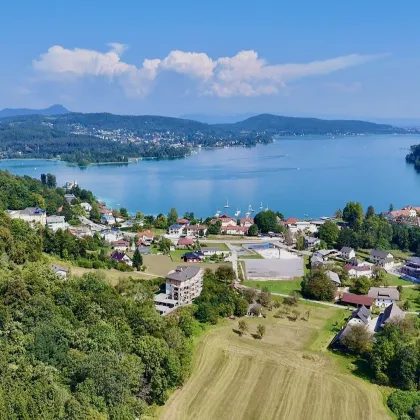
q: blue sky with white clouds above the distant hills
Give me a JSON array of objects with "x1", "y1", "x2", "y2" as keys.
[{"x1": 0, "y1": 0, "x2": 420, "y2": 119}]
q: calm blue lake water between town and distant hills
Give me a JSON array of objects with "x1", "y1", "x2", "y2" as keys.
[{"x1": 0, "y1": 135, "x2": 420, "y2": 218}]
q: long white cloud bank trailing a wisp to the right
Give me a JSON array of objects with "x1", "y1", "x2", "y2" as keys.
[{"x1": 32, "y1": 42, "x2": 381, "y2": 97}]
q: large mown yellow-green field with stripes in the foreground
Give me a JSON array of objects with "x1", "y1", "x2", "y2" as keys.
[{"x1": 160, "y1": 305, "x2": 391, "y2": 420}]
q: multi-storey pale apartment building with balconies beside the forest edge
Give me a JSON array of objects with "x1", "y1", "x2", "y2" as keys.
[{"x1": 155, "y1": 265, "x2": 203, "y2": 315}]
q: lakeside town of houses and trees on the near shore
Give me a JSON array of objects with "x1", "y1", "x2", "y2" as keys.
[{"x1": 7, "y1": 177, "x2": 420, "y2": 346}]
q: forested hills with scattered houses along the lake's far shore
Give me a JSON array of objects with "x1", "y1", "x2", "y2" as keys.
[{"x1": 0, "y1": 113, "x2": 408, "y2": 165}]
